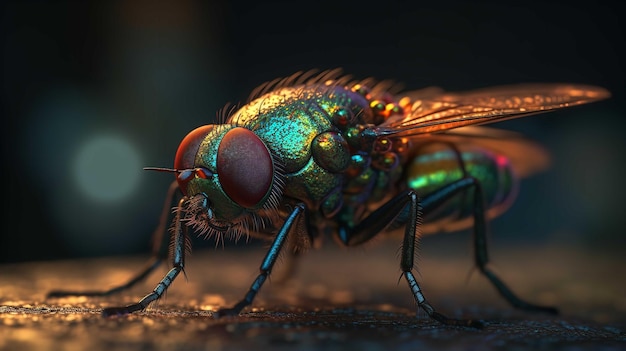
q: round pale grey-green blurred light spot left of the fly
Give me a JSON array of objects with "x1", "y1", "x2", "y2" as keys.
[{"x1": 74, "y1": 136, "x2": 141, "y2": 202}]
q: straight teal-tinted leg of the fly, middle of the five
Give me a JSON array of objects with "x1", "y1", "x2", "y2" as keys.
[{"x1": 213, "y1": 204, "x2": 304, "y2": 318}]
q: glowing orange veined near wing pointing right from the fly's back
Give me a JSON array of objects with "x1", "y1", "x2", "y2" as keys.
[{"x1": 375, "y1": 84, "x2": 610, "y2": 136}]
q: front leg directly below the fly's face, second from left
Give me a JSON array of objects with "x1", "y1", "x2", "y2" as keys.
[{"x1": 102, "y1": 198, "x2": 188, "y2": 317}]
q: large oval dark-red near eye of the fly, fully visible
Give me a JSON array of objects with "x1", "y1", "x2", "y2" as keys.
[{"x1": 217, "y1": 127, "x2": 274, "y2": 208}]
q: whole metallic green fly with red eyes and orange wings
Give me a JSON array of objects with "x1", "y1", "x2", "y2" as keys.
[{"x1": 48, "y1": 70, "x2": 610, "y2": 328}]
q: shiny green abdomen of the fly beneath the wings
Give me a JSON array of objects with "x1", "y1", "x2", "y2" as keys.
[{"x1": 406, "y1": 142, "x2": 518, "y2": 231}]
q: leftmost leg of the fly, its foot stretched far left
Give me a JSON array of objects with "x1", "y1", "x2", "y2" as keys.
[{"x1": 46, "y1": 181, "x2": 178, "y2": 298}]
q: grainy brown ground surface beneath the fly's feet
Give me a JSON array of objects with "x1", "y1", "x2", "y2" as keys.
[{"x1": 0, "y1": 244, "x2": 626, "y2": 351}]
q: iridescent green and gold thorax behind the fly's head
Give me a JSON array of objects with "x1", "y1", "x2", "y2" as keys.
[{"x1": 227, "y1": 84, "x2": 372, "y2": 216}]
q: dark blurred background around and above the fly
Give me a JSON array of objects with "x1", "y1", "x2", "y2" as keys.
[{"x1": 0, "y1": 0, "x2": 626, "y2": 262}]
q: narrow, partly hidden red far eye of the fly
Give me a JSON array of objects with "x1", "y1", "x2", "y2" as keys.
[{"x1": 174, "y1": 124, "x2": 214, "y2": 195}]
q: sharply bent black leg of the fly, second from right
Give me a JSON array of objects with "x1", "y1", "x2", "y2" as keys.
[{"x1": 340, "y1": 190, "x2": 482, "y2": 328}]
